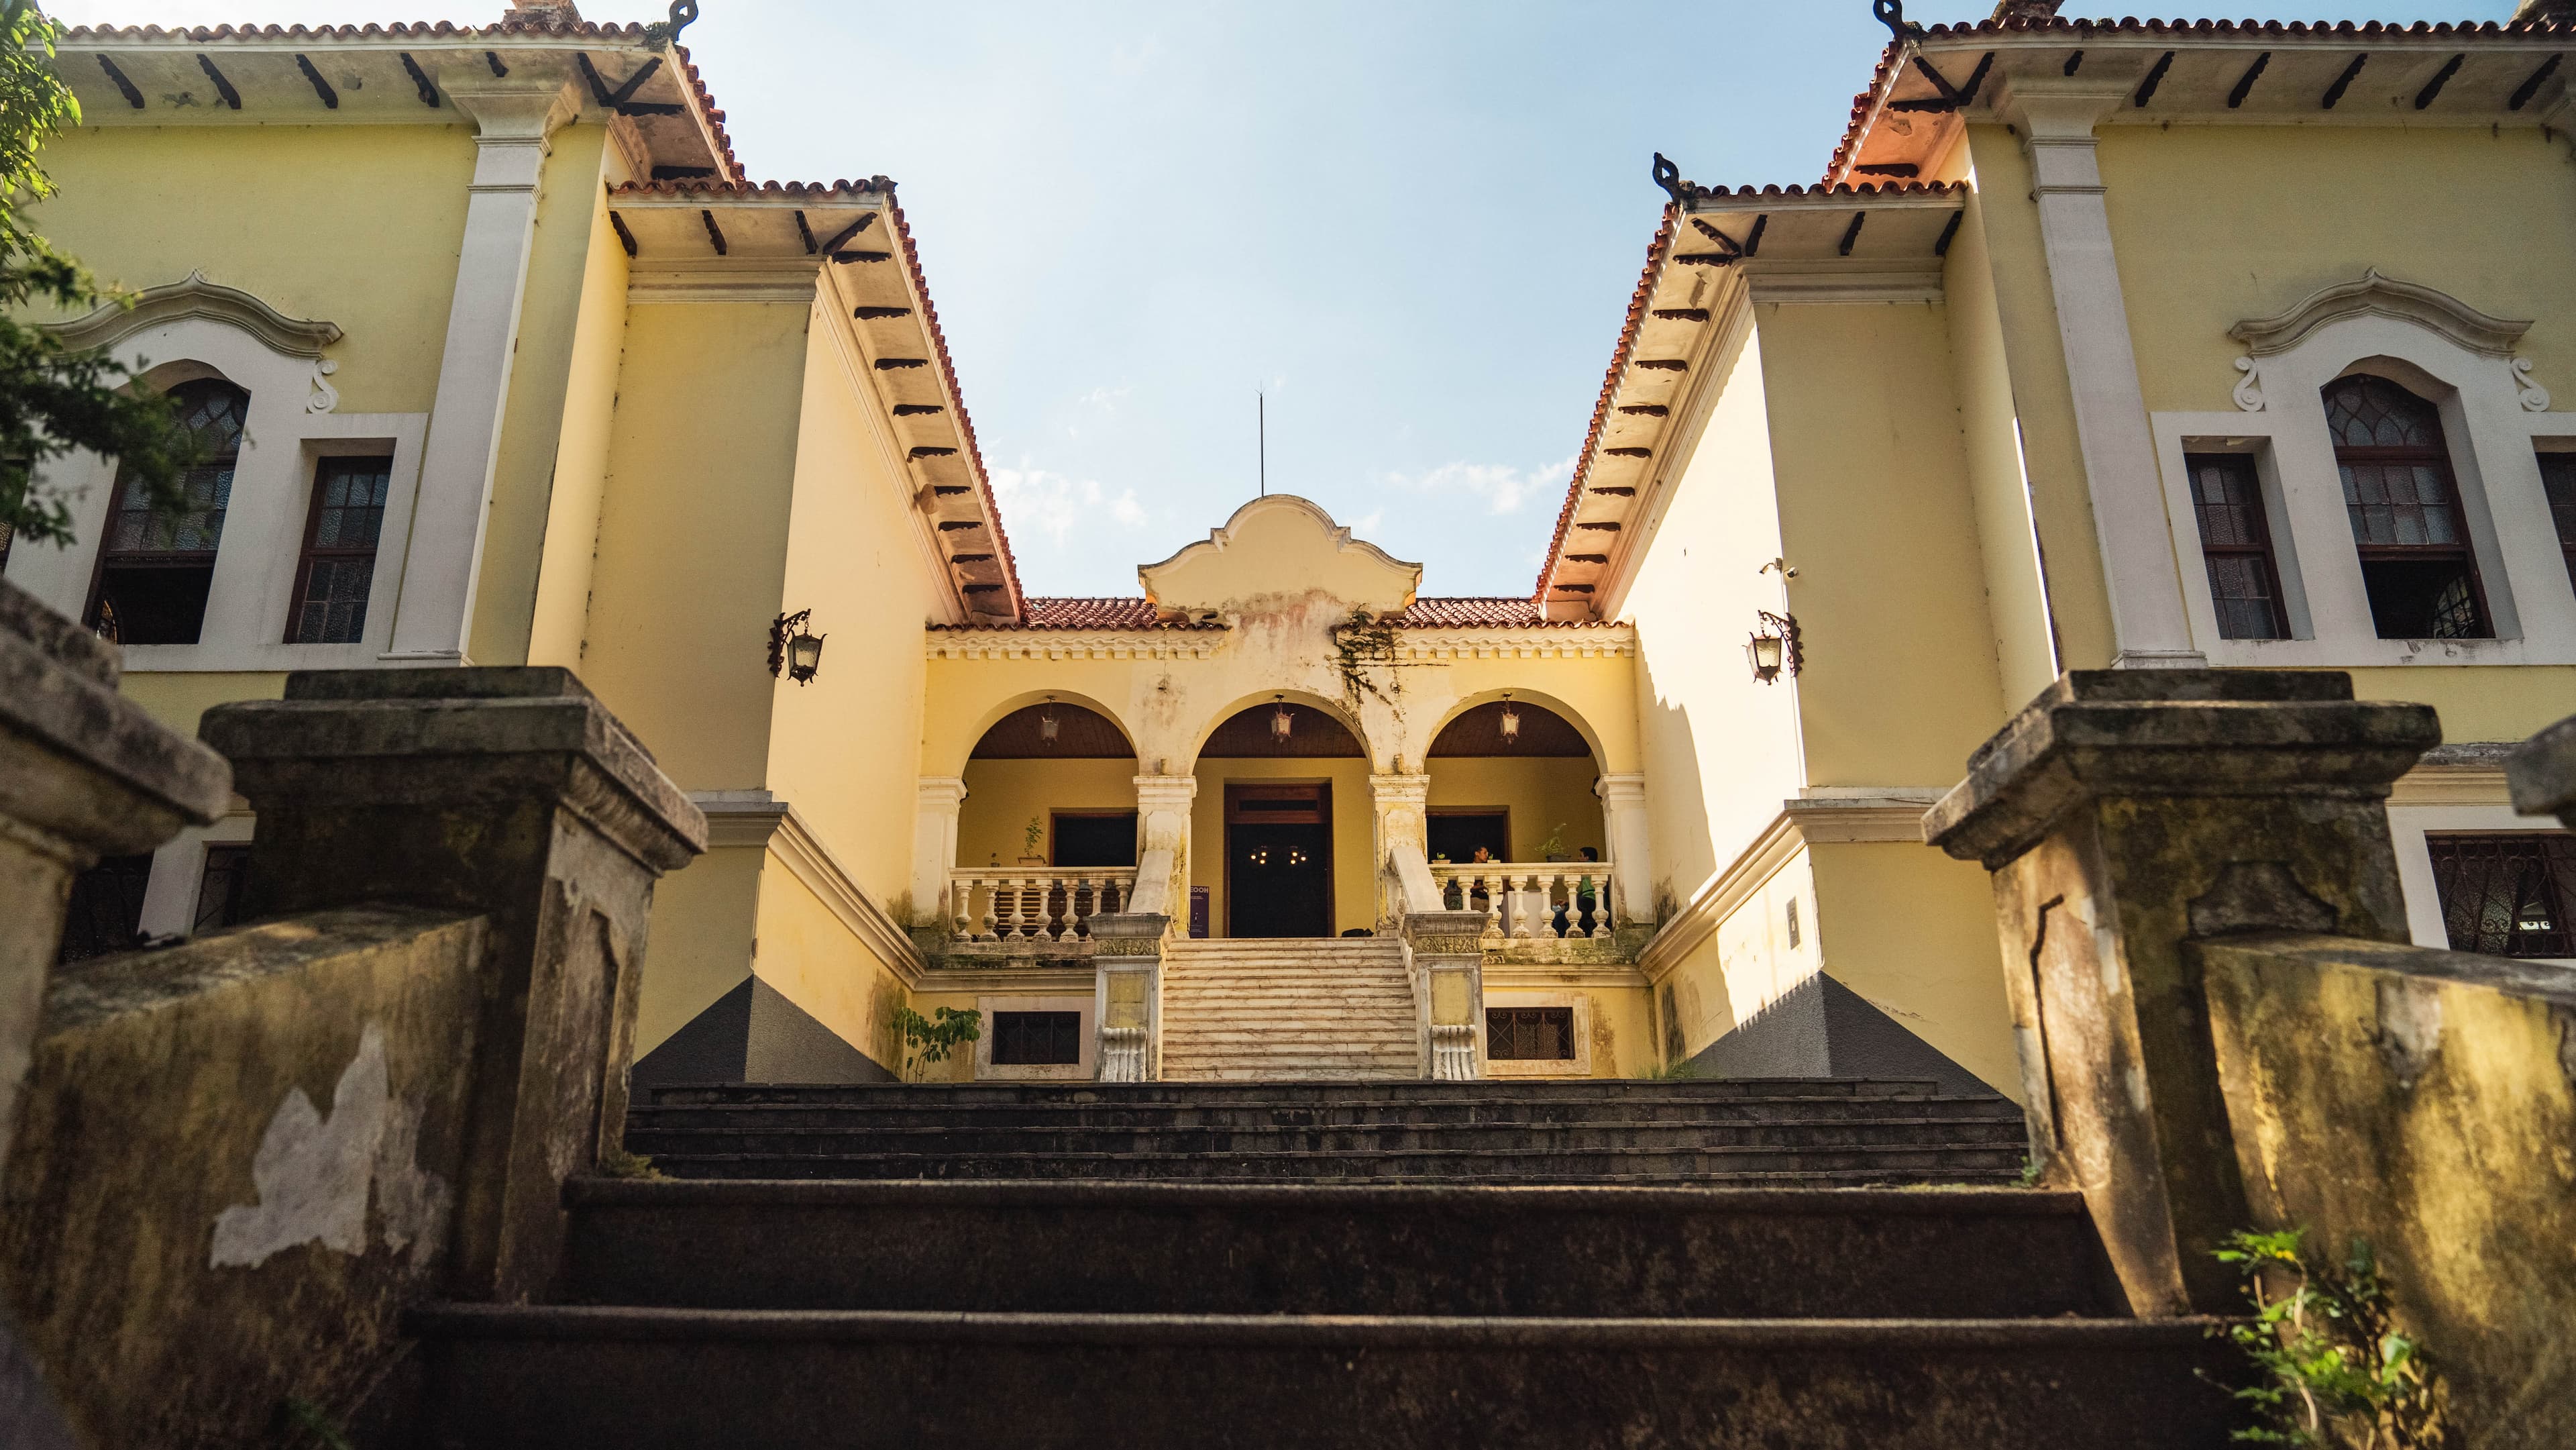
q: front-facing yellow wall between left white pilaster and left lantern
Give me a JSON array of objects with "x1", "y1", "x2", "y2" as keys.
[{"x1": 582, "y1": 304, "x2": 798, "y2": 796}]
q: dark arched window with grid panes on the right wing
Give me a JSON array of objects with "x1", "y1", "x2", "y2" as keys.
[{"x1": 2326, "y1": 374, "x2": 2496, "y2": 639}]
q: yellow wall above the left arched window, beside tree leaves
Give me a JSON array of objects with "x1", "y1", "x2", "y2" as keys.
[{"x1": 34, "y1": 126, "x2": 474, "y2": 412}]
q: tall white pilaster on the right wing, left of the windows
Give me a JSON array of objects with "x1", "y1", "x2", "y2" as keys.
[{"x1": 1999, "y1": 74, "x2": 2208, "y2": 670}]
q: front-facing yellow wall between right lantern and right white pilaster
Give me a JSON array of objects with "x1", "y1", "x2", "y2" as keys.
[{"x1": 1754, "y1": 301, "x2": 2004, "y2": 786}]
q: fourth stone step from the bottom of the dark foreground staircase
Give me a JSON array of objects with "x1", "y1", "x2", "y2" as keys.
[{"x1": 629, "y1": 1097, "x2": 2022, "y2": 1133}]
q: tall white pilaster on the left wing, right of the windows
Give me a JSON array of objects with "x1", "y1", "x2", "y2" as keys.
[{"x1": 384, "y1": 85, "x2": 574, "y2": 664}]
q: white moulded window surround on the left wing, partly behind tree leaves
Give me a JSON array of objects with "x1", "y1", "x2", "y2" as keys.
[{"x1": 8, "y1": 317, "x2": 430, "y2": 675}]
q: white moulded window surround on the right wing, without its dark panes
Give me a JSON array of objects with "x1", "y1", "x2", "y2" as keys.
[{"x1": 2149, "y1": 314, "x2": 2576, "y2": 670}]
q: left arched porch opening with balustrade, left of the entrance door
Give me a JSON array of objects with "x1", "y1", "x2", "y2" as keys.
[{"x1": 948, "y1": 695, "x2": 1136, "y2": 943}]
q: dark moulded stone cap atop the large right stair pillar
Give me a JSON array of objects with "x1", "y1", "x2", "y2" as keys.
[{"x1": 1922, "y1": 670, "x2": 2442, "y2": 870}]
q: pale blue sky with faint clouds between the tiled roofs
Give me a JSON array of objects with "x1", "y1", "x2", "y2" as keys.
[{"x1": 54, "y1": 0, "x2": 2512, "y2": 595}]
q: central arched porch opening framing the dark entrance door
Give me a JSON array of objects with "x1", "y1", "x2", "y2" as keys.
[{"x1": 1190, "y1": 693, "x2": 1376, "y2": 937}]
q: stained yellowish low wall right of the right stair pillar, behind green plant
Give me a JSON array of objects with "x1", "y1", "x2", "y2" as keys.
[{"x1": 2200, "y1": 935, "x2": 2576, "y2": 1450}]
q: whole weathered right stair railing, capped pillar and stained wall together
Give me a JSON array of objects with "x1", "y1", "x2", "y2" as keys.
[{"x1": 1924, "y1": 670, "x2": 2576, "y2": 1445}]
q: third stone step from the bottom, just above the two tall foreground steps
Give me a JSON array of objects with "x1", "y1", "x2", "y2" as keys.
[{"x1": 612, "y1": 1136, "x2": 2025, "y2": 1182}]
